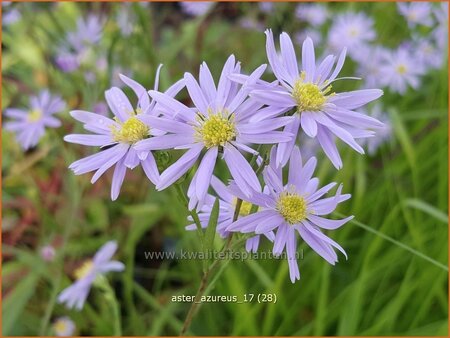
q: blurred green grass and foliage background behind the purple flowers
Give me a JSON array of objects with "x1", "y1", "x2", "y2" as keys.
[{"x1": 2, "y1": 3, "x2": 448, "y2": 336}]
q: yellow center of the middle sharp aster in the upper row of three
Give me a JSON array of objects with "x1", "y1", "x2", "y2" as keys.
[{"x1": 197, "y1": 114, "x2": 236, "y2": 148}]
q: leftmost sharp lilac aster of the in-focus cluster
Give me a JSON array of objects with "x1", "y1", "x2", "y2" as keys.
[{"x1": 64, "y1": 67, "x2": 184, "y2": 200}]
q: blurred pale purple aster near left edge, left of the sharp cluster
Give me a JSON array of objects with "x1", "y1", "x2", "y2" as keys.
[{"x1": 4, "y1": 90, "x2": 66, "y2": 150}]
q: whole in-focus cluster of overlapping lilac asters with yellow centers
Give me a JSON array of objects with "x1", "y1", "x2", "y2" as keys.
[{"x1": 63, "y1": 30, "x2": 383, "y2": 284}]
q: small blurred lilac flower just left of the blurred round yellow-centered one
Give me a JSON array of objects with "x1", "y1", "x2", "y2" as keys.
[{"x1": 355, "y1": 45, "x2": 389, "y2": 88}]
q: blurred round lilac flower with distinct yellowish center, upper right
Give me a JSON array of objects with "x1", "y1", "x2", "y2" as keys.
[{"x1": 380, "y1": 47, "x2": 424, "y2": 94}]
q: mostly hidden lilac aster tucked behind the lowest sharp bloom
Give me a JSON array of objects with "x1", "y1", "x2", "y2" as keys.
[{"x1": 186, "y1": 175, "x2": 275, "y2": 252}]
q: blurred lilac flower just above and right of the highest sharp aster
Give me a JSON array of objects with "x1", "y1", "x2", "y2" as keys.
[{"x1": 328, "y1": 12, "x2": 376, "y2": 58}]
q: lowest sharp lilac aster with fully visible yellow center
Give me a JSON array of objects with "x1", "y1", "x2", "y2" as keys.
[{"x1": 226, "y1": 147, "x2": 353, "y2": 283}]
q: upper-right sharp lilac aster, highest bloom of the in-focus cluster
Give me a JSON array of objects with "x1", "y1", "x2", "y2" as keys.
[{"x1": 250, "y1": 30, "x2": 383, "y2": 169}]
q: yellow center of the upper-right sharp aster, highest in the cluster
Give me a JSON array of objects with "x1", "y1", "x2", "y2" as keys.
[{"x1": 292, "y1": 71, "x2": 331, "y2": 113}]
